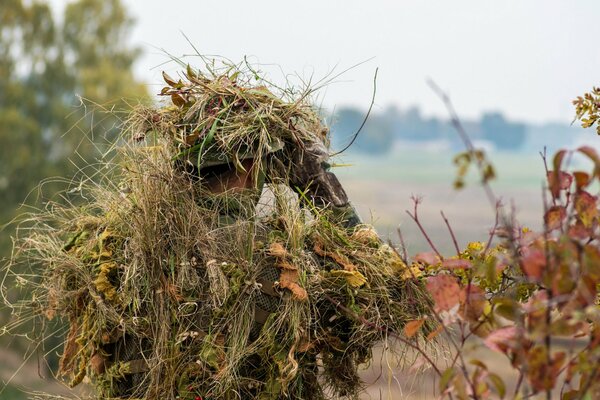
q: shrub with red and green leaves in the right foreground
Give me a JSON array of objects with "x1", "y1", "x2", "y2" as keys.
[{"x1": 386, "y1": 89, "x2": 600, "y2": 400}]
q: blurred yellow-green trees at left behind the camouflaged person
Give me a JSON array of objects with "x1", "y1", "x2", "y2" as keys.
[{"x1": 0, "y1": 0, "x2": 148, "y2": 230}]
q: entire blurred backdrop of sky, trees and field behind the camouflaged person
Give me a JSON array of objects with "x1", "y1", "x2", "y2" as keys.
[{"x1": 0, "y1": 0, "x2": 600, "y2": 399}]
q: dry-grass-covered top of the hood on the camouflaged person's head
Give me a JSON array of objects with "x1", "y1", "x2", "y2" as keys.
[{"x1": 131, "y1": 67, "x2": 329, "y2": 184}]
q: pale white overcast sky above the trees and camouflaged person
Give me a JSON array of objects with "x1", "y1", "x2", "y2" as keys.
[{"x1": 50, "y1": 0, "x2": 600, "y2": 123}]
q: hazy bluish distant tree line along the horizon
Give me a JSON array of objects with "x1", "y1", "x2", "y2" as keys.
[{"x1": 330, "y1": 106, "x2": 582, "y2": 154}]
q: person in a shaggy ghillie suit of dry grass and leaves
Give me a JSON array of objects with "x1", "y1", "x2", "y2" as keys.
[{"x1": 8, "y1": 64, "x2": 429, "y2": 399}]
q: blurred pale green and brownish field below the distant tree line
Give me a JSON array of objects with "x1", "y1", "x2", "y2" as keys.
[{"x1": 335, "y1": 148, "x2": 545, "y2": 254}]
